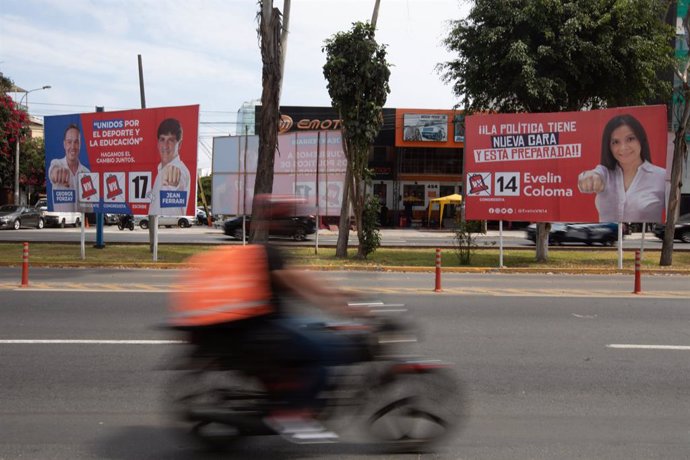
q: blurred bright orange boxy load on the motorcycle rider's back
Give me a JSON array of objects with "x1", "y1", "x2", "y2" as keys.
[{"x1": 171, "y1": 245, "x2": 273, "y2": 327}]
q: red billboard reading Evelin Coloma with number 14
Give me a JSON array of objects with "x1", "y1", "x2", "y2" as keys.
[{"x1": 465, "y1": 106, "x2": 668, "y2": 222}]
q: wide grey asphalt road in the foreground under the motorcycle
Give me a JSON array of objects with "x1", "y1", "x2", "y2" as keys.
[{"x1": 0, "y1": 268, "x2": 690, "y2": 460}]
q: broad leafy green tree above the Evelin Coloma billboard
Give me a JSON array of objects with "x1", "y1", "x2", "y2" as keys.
[{"x1": 439, "y1": 0, "x2": 672, "y2": 261}]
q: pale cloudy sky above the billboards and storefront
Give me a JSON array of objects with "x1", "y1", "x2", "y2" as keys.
[{"x1": 0, "y1": 0, "x2": 470, "y2": 169}]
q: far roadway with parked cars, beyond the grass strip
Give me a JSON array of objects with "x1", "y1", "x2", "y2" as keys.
[{"x1": 0, "y1": 225, "x2": 672, "y2": 250}]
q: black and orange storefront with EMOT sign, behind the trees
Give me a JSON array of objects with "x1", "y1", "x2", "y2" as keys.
[{"x1": 268, "y1": 106, "x2": 465, "y2": 226}]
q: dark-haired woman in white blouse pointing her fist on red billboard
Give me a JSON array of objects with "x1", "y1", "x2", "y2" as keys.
[{"x1": 578, "y1": 115, "x2": 666, "y2": 222}]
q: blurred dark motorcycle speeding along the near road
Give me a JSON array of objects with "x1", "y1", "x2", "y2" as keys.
[{"x1": 166, "y1": 303, "x2": 464, "y2": 452}]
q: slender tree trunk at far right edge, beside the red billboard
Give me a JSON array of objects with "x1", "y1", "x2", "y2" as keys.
[{"x1": 659, "y1": 1, "x2": 690, "y2": 266}]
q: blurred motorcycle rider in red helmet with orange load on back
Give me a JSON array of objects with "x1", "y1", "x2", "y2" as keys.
[{"x1": 173, "y1": 195, "x2": 366, "y2": 442}]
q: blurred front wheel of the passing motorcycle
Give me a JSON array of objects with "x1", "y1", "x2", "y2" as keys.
[{"x1": 364, "y1": 369, "x2": 466, "y2": 452}]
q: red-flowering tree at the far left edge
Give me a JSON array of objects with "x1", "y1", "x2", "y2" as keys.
[{"x1": 0, "y1": 74, "x2": 30, "y2": 202}]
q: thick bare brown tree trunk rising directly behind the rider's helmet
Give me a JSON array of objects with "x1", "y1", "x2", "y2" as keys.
[{"x1": 249, "y1": 0, "x2": 290, "y2": 241}]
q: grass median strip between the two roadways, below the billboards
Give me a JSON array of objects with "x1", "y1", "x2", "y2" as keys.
[{"x1": 0, "y1": 243, "x2": 690, "y2": 270}]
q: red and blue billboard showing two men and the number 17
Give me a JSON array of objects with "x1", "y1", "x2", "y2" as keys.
[{"x1": 44, "y1": 105, "x2": 199, "y2": 215}]
